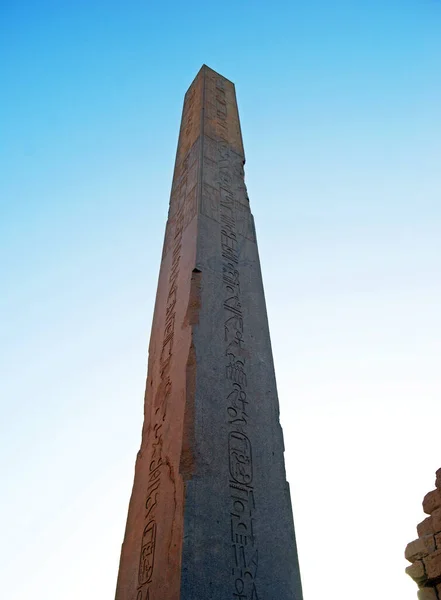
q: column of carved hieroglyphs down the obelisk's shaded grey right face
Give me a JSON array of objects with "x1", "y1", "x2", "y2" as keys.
[{"x1": 211, "y1": 78, "x2": 259, "y2": 600}]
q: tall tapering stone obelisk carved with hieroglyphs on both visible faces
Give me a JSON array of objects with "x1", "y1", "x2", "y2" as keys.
[{"x1": 116, "y1": 66, "x2": 302, "y2": 600}]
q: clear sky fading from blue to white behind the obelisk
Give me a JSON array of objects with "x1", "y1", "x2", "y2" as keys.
[{"x1": 0, "y1": 0, "x2": 441, "y2": 600}]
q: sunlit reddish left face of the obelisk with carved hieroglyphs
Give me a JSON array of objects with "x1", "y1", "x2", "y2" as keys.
[{"x1": 116, "y1": 69, "x2": 202, "y2": 600}]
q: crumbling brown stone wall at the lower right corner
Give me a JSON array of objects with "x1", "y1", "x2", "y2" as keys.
[{"x1": 405, "y1": 469, "x2": 441, "y2": 600}]
